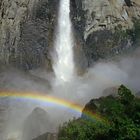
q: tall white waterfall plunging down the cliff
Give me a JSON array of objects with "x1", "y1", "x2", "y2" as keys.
[{"x1": 53, "y1": 0, "x2": 74, "y2": 81}]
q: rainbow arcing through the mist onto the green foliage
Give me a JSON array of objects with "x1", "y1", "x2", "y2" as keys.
[{"x1": 0, "y1": 91, "x2": 109, "y2": 124}]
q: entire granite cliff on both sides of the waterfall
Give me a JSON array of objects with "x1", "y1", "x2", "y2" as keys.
[{"x1": 0, "y1": 0, "x2": 140, "y2": 70}]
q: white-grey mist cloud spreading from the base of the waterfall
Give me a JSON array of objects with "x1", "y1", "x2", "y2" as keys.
[{"x1": 0, "y1": 49, "x2": 140, "y2": 139}]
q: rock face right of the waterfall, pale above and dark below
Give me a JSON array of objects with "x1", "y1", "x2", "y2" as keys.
[{"x1": 71, "y1": 0, "x2": 140, "y2": 66}]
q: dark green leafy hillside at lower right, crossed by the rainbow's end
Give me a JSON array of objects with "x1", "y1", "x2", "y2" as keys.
[{"x1": 58, "y1": 85, "x2": 140, "y2": 140}]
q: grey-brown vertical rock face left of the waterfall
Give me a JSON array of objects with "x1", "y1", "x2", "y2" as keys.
[{"x1": 0, "y1": 0, "x2": 58, "y2": 69}]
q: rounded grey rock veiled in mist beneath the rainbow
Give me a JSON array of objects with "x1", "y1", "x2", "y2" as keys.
[{"x1": 22, "y1": 108, "x2": 51, "y2": 140}]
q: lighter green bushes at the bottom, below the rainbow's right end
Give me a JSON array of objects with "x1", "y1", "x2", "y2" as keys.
[{"x1": 59, "y1": 119, "x2": 109, "y2": 140}]
